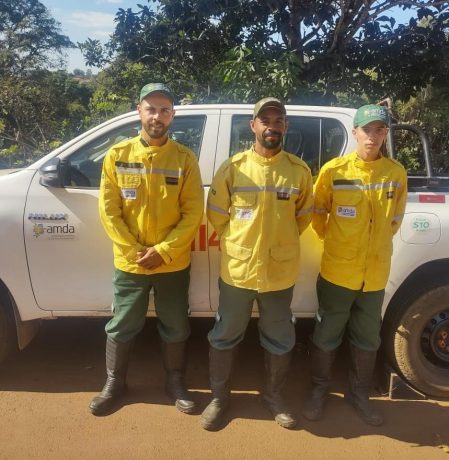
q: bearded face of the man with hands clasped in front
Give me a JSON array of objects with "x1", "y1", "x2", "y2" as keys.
[{"x1": 137, "y1": 93, "x2": 175, "y2": 139}]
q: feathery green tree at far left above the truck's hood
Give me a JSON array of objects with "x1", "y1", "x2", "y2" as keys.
[{"x1": 0, "y1": 0, "x2": 79, "y2": 164}]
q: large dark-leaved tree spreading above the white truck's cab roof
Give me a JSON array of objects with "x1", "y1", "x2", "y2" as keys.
[{"x1": 83, "y1": 0, "x2": 449, "y2": 102}]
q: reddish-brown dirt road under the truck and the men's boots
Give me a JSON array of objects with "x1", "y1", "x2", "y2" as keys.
[{"x1": 0, "y1": 319, "x2": 449, "y2": 460}]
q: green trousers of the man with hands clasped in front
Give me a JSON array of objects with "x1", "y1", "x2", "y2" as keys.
[{"x1": 105, "y1": 267, "x2": 190, "y2": 343}]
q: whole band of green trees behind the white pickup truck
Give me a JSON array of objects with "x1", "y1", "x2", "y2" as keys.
[{"x1": 0, "y1": 0, "x2": 449, "y2": 169}]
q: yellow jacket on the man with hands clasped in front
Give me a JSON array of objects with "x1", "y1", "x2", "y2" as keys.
[{"x1": 99, "y1": 136, "x2": 204, "y2": 274}]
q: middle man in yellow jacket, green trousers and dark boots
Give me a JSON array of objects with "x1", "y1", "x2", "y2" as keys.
[{"x1": 201, "y1": 97, "x2": 313, "y2": 430}]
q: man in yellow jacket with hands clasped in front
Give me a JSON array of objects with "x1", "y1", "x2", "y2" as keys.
[{"x1": 90, "y1": 83, "x2": 204, "y2": 415}]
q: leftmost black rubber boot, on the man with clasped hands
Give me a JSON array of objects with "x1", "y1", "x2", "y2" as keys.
[{"x1": 89, "y1": 337, "x2": 133, "y2": 415}]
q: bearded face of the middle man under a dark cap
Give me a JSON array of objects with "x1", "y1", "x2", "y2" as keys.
[{"x1": 251, "y1": 107, "x2": 288, "y2": 150}]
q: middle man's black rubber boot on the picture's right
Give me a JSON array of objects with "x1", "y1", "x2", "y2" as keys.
[{"x1": 262, "y1": 351, "x2": 296, "y2": 428}]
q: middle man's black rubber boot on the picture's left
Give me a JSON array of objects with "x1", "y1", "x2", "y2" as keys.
[{"x1": 201, "y1": 347, "x2": 235, "y2": 431}]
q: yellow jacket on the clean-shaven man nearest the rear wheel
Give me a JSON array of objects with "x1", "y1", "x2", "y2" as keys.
[{"x1": 312, "y1": 152, "x2": 407, "y2": 291}]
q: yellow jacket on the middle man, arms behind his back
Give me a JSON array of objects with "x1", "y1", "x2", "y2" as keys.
[{"x1": 207, "y1": 149, "x2": 313, "y2": 292}]
